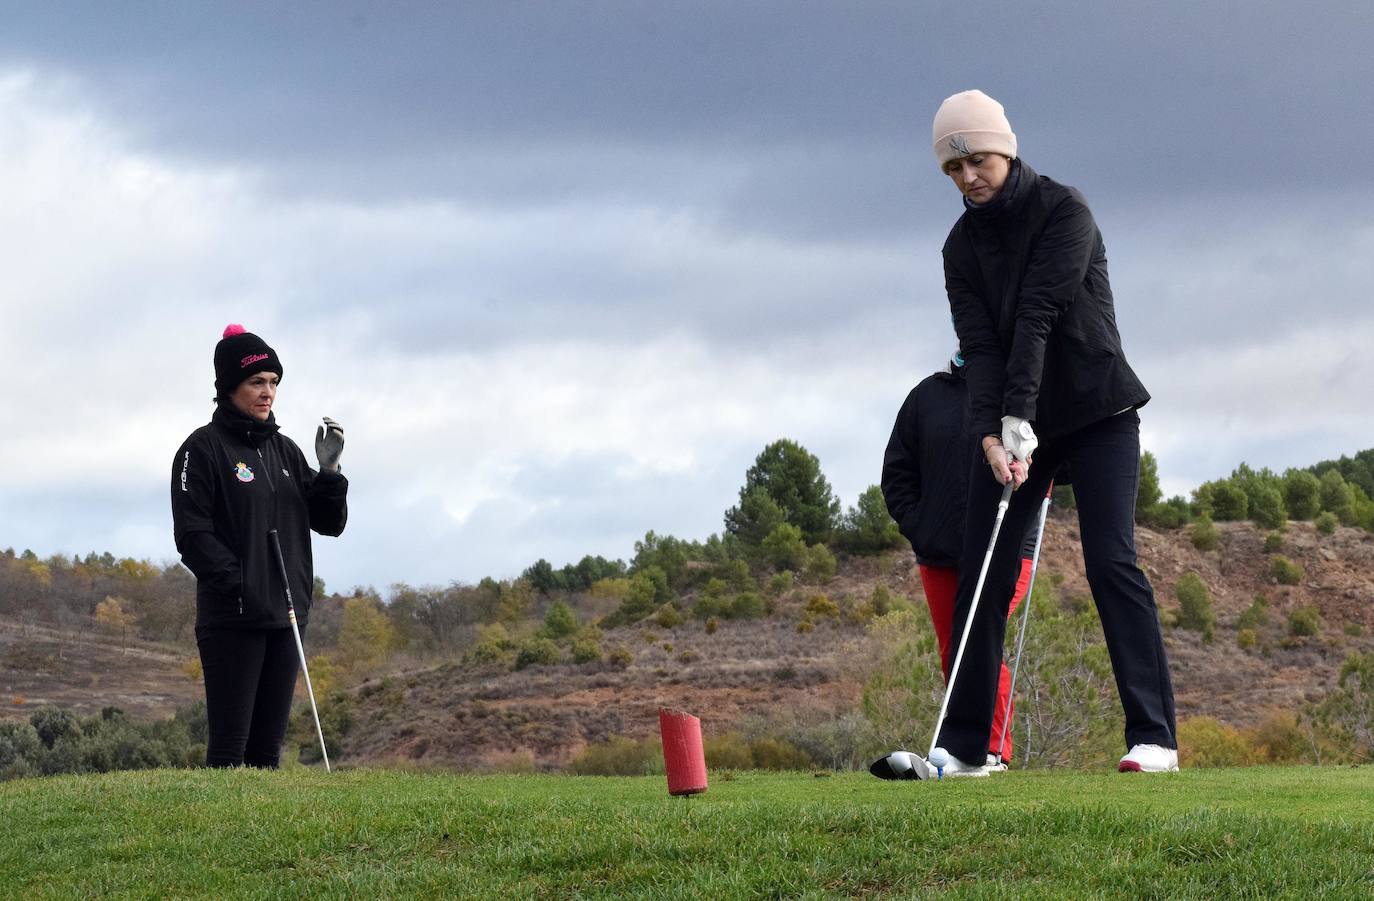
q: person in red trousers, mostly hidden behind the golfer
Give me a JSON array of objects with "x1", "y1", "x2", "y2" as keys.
[{"x1": 882, "y1": 353, "x2": 1036, "y2": 771}]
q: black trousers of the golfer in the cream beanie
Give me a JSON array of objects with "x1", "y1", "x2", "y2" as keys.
[{"x1": 937, "y1": 411, "x2": 1178, "y2": 762}]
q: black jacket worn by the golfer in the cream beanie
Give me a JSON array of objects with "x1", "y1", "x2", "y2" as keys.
[{"x1": 944, "y1": 159, "x2": 1150, "y2": 441}]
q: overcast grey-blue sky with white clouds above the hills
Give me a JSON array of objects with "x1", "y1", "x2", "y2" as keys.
[{"x1": 0, "y1": 0, "x2": 1374, "y2": 589}]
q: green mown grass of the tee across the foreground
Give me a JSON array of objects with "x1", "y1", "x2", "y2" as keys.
[{"x1": 0, "y1": 768, "x2": 1374, "y2": 900}]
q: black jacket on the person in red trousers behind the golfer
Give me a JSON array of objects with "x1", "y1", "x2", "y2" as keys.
[{"x1": 881, "y1": 365, "x2": 1049, "y2": 567}]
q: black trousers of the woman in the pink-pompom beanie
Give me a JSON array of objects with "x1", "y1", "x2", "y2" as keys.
[{"x1": 196, "y1": 626, "x2": 305, "y2": 769}]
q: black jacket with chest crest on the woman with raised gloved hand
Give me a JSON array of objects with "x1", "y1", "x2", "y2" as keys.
[{"x1": 172, "y1": 404, "x2": 348, "y2": 633}]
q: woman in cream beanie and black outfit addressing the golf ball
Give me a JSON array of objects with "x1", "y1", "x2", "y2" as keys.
[{"x1": 932, "y1": 91, "x2": 1178, "y2": 773}]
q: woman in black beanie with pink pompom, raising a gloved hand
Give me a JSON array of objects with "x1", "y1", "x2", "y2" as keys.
[{"x1": 172, "y1": 326, "x2": 348, "y2": 768}]
